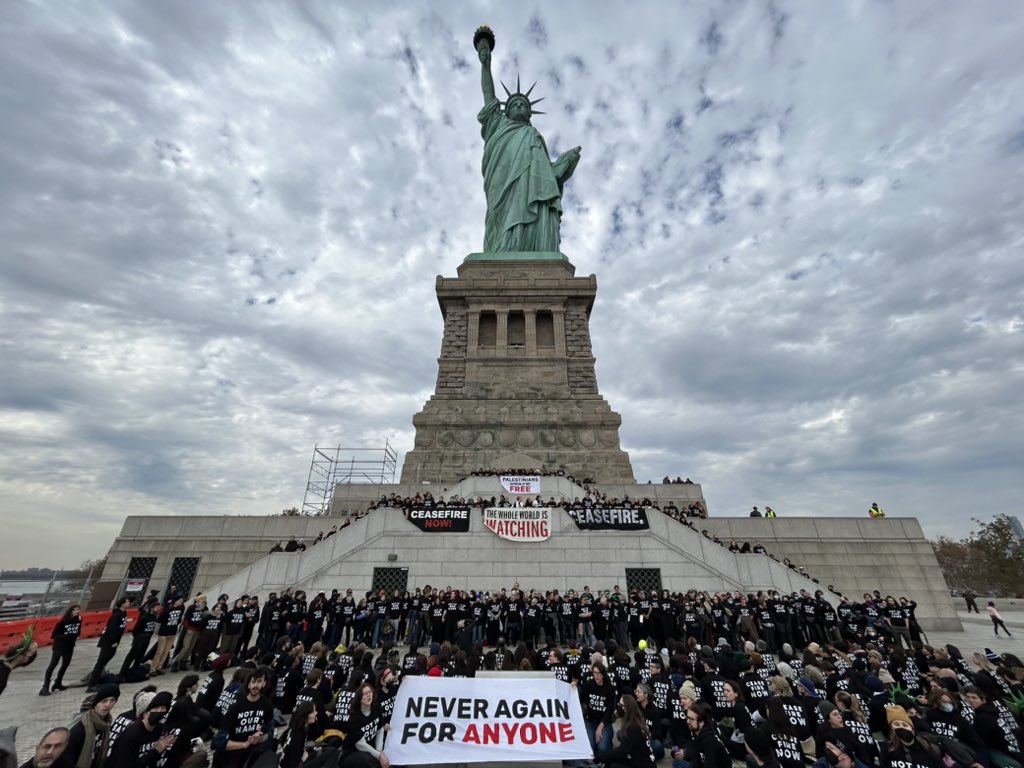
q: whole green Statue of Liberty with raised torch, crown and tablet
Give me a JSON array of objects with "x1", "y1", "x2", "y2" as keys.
[{"x1": 473, "y1": 27, "x2": 580, "y2": 253}]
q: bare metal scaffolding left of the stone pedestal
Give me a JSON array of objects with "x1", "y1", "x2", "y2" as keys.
[{"x1": 302, "y1": 440, "x2": 398, "y2": 517}]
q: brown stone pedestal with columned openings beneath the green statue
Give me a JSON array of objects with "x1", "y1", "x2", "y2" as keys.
[{"x1": 401, "y1": 259, "x2": 634, "y2": 484}]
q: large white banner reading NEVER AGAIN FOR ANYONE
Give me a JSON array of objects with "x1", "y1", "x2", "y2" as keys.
[{"x1": 384, "y1": 677, "x2": 594, "y2": 765}]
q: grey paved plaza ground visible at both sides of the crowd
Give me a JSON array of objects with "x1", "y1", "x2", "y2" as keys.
[{"x1": 0, "y1": 600, "x2": 1024, "y2": 764}]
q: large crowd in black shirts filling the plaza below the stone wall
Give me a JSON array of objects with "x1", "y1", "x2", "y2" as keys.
[{"x1": 0, "y1": 584, "x2": 1024, "y2": 768}]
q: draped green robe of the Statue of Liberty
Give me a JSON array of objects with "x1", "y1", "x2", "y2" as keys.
[{"x1": 477, "y1": 98, "x2": 562, "y2": 253}]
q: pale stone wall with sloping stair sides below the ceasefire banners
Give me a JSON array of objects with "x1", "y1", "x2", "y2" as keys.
[{"x1": 207, "y1": 505, "x2": 835, "y2": 597}]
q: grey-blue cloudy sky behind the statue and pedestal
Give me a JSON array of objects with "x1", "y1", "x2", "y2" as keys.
[{"x1": 0, "y1": 0, "x2": 1024, "y2": 567}]
